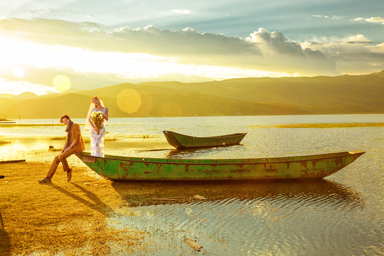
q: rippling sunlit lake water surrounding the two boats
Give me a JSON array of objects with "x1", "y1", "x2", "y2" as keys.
[{"x1": 0, "y1": 115, "x2": 384, "y2": 255}]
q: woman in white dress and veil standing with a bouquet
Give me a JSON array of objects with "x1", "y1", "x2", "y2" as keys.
[{"x1": 88, "y1": 96, "x2": 108, "y2": 157}]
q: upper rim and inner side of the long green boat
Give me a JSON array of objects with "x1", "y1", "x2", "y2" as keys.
[{"x1": 76, "y1": 151, "x2": 365, "y2": 165}]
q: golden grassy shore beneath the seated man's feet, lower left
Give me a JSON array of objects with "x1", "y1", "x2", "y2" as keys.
[{"x1": 0, "y1": 163, "x2": 145, "y2": 255}]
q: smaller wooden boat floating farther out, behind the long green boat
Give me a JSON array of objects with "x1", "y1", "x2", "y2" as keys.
[{"x1": 163, "y1": 131, "x2": 247, "y2": 149}]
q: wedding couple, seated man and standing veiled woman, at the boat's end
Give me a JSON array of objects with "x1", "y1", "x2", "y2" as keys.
[{"x1": 39, "y1": 97, "x2": 108, "y2": 183}]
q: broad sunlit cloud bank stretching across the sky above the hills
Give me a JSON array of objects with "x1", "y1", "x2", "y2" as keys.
[{"x1": 0, "y1": 19, "x2": 384, "y2": 88}]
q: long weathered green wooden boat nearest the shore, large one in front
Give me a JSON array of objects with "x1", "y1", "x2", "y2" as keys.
[{"x1": 77, "y1": 151, "x2": 365, "y2": 181}]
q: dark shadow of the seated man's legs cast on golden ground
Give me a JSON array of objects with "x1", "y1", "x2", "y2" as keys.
[{"x1": 50, "y1": 183, "x2": 113, "y2": 217}]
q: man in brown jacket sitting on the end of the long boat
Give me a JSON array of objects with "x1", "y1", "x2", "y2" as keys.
[{"x1": 39, "y1": 115, "x2": 85, "y2": 183}]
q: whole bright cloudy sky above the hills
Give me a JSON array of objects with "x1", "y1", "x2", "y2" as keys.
[{"x1": 0, "y1": 0, "x2": 384, "y2": 94}]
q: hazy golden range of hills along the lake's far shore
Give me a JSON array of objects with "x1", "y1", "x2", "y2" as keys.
[{"x1": 0, "y1": 71, "x2": 384, "y2": 118}]
